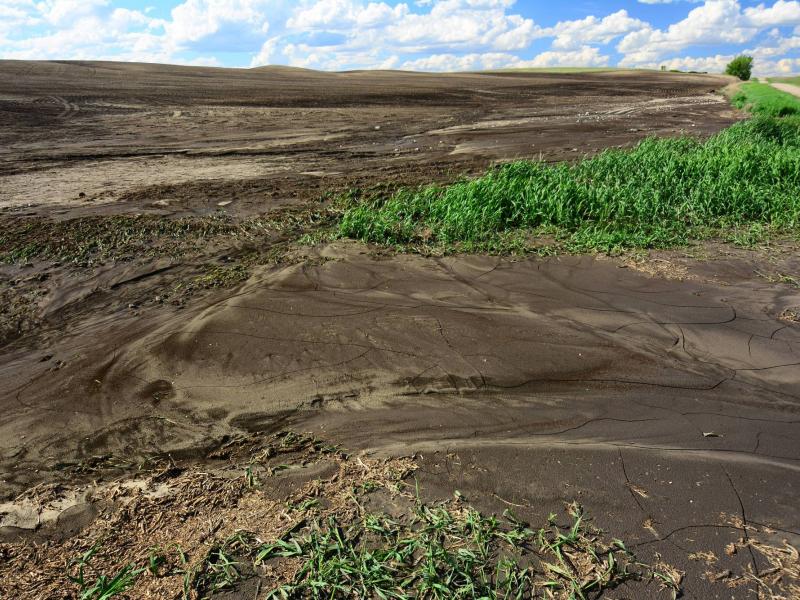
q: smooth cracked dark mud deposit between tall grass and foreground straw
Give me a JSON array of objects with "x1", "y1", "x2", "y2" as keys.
[{"x1": 0, "y1": 244, "x2": 800, "y2": 598}]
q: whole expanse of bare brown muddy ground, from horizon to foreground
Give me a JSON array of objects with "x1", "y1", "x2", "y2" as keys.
[{"x1": 0, "y1": 62, "x2": 800, "y2": 598}]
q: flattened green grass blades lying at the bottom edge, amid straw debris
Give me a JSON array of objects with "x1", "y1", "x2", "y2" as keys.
[{"x1": 255, "y1": 501, "x2": 677, "y2": 600}]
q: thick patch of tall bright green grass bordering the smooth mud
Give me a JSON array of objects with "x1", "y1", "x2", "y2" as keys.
[{"x1": 340, "y1": 116, "x2": 800, "y2": 251}]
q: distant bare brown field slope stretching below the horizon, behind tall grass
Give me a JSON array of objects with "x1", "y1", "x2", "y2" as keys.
[{"x1": 0, "y1": 61, "x2": 737, "y2": 218}]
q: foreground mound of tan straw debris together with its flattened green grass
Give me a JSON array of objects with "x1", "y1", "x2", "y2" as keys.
[{"x1": 0, "y1": 433, "x2": 682, "y2": 600}]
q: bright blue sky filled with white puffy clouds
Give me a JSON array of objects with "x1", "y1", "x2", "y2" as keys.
[{"x1": 0, "y1": 0, "x2": 800, "y2": 76}]
